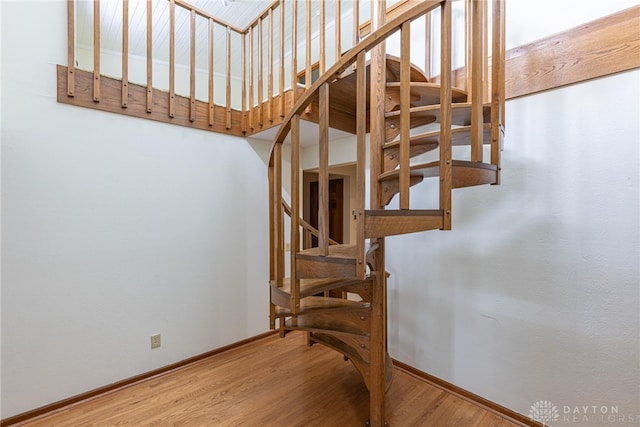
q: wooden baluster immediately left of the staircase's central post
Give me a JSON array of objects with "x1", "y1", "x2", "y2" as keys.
[{"x1": 356, "y1": 52, "x2": 367, "y2": 279}]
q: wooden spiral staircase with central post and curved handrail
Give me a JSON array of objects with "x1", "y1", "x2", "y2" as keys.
[{"x1": 269, "y1": 0, "x2": 504, "y2": 426}]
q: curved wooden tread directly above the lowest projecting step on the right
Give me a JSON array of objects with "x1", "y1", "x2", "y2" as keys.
[{"x1": 379, "y1": 160, "x2": 498, "y2": 188}]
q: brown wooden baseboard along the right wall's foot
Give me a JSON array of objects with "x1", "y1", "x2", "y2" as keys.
[{"x1": 393, "y1": 359, "x2": 543, "y2": 427}]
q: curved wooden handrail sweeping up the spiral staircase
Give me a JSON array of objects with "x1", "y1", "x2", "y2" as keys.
[{"x1": 274, "y1": 0, "x2": 442, "y2": 152}]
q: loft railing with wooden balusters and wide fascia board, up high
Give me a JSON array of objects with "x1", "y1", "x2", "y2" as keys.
[{"x1": 59, "y1": 0, "x2": 502, "y2": 135}]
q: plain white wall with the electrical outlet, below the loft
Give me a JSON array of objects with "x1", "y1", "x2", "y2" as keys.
[{"x1": 0, "y1": 1, "x2": 268, "y2": 418}]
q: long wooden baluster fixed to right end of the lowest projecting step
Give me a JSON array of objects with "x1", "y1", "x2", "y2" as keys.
[{"x1": 440, "y1": 0, "x2": 453, "y2": 230}]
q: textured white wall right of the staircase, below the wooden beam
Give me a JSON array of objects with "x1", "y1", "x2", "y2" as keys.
[{"x1": 387, "y1": 71, "x2": 640, "y2": 425}]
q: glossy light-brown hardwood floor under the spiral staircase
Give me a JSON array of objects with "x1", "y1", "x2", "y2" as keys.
[{"x1": 17, "y1": 332, "x2": 518, "y2": 427}]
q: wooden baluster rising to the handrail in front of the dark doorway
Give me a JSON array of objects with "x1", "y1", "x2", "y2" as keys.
[{"x1": 318, "y1": 83, "x2": 329, "y2": 256}]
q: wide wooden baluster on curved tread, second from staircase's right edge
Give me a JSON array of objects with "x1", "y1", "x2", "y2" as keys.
[{"x1": 471, "y1": 1, "x2": 484, "y2": 162}]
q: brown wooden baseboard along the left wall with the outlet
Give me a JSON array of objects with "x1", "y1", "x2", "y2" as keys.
[{"x1": 0, "y1": 332, "x2": 278, "y2": 427}]
